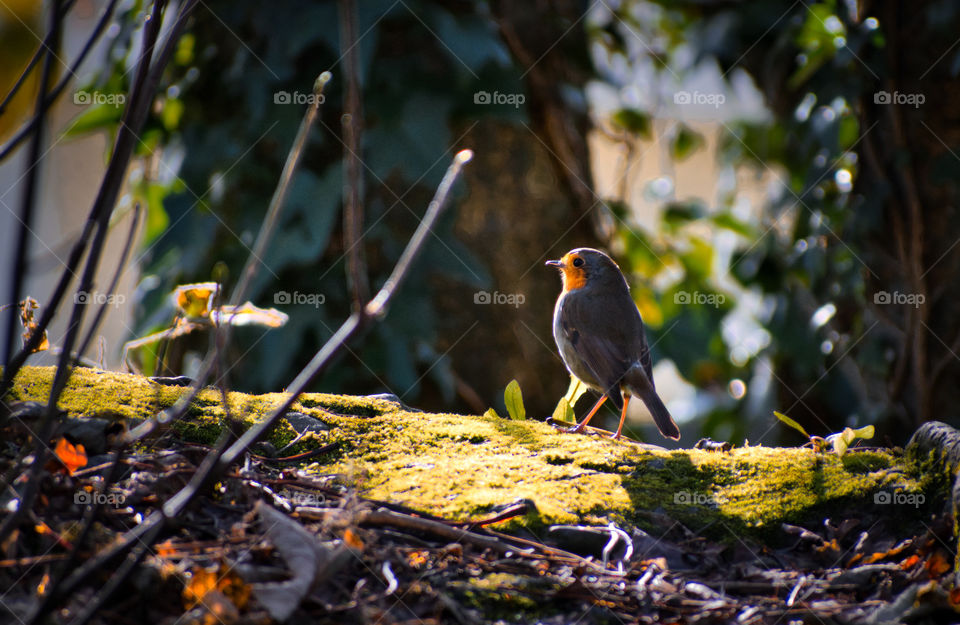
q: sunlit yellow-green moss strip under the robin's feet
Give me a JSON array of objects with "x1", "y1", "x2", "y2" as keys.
[{"x1": 7, "y1": 367, "x2": 930, "y2": 534}]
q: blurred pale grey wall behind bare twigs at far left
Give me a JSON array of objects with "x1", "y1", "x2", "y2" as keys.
[{"x1": 0, "y1": 0, "x2": 142, "y2": 369}]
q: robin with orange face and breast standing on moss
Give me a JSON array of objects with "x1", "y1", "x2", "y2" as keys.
[{"x1": 547, "y1": 247, "x2": 680, "y2": 440}]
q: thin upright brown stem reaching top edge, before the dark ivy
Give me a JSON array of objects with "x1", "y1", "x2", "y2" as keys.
[{"x1": 340, "y1": 0, "x2": 370, "y2": 312}]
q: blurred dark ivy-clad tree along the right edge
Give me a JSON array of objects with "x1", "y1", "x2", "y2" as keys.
[{"x1": 600, "y1": 2, "x2": 960, "y2": 441}]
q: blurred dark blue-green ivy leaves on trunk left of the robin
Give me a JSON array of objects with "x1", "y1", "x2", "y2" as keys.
[{"x1": 75, "y1": 1, "x2": 526, "y2": 401}]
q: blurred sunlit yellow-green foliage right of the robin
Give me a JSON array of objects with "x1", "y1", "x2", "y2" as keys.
[{"x1": 592, "y1": 1, "x2": 960, "y2": 440}]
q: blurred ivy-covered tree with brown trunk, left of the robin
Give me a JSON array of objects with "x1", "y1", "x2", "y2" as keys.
[{"x1": 81, "y1": 2, "x2": 598, "y2": 420}]
